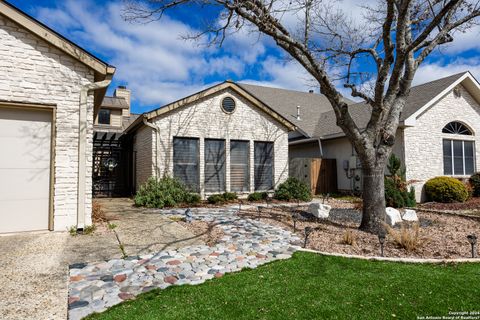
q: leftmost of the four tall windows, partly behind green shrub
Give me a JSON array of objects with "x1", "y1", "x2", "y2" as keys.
[{"x1": 173, "y1": 137, "x2": 200, "y2": 192}]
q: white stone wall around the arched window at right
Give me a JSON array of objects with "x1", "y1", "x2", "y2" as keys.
[{"x1": 404, "y1": 85, "x2": 480, "y2": 201}]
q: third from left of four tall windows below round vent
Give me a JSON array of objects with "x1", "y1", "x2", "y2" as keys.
[{"x1": 230, "y1": 140, "x2": 250, "y2": 192}]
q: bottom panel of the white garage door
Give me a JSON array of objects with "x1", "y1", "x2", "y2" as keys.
[{"x1": 0, "y1": 199, "x2": 48, "y2": 233}]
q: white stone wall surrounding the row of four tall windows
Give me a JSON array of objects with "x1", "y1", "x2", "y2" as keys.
[{"x1": 136, "y1": 89, "x2": 288, "y2": 196}]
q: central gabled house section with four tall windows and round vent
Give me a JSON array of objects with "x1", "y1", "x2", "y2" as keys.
[{"x1": 127, "y1": 81, "x2": 295, "y2": 196}]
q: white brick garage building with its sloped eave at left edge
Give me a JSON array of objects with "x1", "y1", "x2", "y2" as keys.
[{"x1": 0, "y1": 1, "x2": 115, "y2": 233}]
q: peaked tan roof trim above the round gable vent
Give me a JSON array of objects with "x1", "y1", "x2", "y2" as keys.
[{"x1": 142, "y1": 81, "x2": 296, "y2": 131}]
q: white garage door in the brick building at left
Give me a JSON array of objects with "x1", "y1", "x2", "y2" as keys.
[{"x1": 0, "y1": 106, "x2": 52, "y2": 233}]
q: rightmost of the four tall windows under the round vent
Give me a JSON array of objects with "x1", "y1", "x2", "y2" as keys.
[{"x1": 254, "y1": 141, "x2": 273, "y2": 190}]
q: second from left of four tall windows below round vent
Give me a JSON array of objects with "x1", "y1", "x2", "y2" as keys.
[{"x1": 205, "y1": 139, "x2": 226, "y2": 192}]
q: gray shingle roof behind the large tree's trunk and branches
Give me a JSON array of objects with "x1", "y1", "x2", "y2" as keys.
[{"x1": 238, "y1": 72, "x2": 466, "y2": 137}]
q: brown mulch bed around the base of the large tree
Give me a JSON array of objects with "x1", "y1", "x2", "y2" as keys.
[{"x1": 241, "y1": 199, "x2": 480, "y2": 259}]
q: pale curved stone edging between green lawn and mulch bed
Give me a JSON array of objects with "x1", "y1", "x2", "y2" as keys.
[{"x1": 298, "y1": 248, "x2": 480, "y2": 264}]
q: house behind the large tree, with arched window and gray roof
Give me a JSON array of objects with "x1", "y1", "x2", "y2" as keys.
[{"x1": 280, "y1": 72, "x2": 480, "y2": 201}]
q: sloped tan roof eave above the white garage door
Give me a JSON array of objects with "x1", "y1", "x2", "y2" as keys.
[{"x1": 0, "y1": 0, "x2": 115, "y2": 77}]
